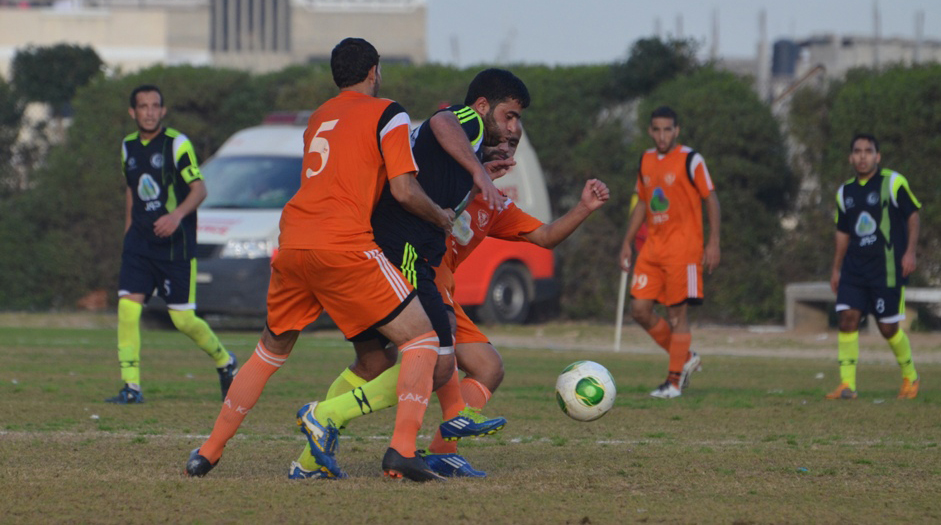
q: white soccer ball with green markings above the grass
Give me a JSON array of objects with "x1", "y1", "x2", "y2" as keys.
[{"x1": 555, "y1": 361, "x2": 617, "y2": 421}]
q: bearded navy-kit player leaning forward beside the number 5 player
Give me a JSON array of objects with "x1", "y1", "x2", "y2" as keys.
[{"x1": 289, "y1": 69, "x2": 530, "y2": 478}]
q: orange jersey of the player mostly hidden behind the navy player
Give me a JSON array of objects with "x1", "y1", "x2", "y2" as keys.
[{"x1": 441, "y1": 194, "x2": 543, "y2": 272}]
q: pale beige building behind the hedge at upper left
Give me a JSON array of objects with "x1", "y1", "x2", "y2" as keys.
[{"x1": 0, "y1": 0, "x2": 427, "y2": 77}]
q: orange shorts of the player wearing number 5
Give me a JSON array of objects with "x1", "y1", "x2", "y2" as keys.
[{"x1": 268, "y1": 248, "x2": 412, "y2": 337}]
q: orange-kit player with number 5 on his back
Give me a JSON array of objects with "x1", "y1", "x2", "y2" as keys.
[{"x1": 185, "y1": 38, "x2": 453, "y2": 481}]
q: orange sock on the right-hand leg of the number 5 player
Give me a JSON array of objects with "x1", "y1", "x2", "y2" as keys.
[{"x1": 388, "y1": 332, "x2": 438, "y2": 458}]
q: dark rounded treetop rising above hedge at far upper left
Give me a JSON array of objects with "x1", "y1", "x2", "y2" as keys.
[{"x1": 11, "y1": 44, "x2": 104, "y2": 116}]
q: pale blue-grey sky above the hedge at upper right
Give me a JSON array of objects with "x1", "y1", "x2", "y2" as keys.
[{"x1": 427, "y1": 0, "x2": 941, "y2": 67}]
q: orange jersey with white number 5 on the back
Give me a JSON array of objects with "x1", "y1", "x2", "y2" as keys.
[{"x1": 278, "y1": 91, "x2": 418, "y2": 251}]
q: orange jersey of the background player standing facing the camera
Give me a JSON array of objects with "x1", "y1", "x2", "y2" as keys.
[{"x1": 636, "y1": 144, "x2": 713, "y2": 264}]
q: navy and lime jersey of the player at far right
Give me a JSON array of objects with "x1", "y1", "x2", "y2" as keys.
[{"x1": 836, "y1": 169, "x2": 921, "y2": 288}]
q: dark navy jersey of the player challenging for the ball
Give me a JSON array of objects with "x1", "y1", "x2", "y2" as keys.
[{"x1": 372, "y1": 105, "x2": 484, "y2": 266}]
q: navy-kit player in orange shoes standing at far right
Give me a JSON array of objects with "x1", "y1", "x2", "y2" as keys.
[{"x1": 826, "y1": 134, "x2": 921, "y2": 399}]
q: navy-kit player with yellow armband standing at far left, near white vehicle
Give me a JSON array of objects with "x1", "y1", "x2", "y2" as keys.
[{"x1": 106, "y1": 85, "x2": 238, "y2": 404}]
